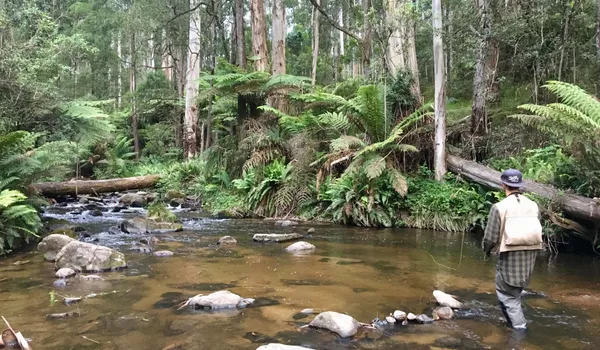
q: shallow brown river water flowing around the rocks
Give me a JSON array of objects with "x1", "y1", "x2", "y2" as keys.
[{"x1": 0, "y1": 205, "x2": 600, "y2": 350}]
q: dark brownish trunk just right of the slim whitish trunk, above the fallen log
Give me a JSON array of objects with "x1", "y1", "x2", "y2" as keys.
[{"x1": 471, "y1": 0, "x2": 491, "y2": 136}]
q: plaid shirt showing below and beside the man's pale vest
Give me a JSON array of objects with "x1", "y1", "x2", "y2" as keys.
[{"x1": 482, "y1": 205, "x2": 537, "y2": 288}]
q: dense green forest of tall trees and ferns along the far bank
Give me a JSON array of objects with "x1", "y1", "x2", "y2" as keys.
[{"x1": 0, "y1": 0, "x2": 600, "y2": 254}]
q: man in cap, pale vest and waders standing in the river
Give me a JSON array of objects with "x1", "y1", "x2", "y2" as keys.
[{"x1": 483, "y1": 169, "x2": 542, "y2": 329}]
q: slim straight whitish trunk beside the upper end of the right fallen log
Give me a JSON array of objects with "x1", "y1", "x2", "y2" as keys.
[{"x1": 431, "y1": 0, "x2": 446, "y2": 181}]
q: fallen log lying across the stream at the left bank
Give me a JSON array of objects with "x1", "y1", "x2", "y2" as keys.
[{"x1": 31, "y1": 175, "x2": 160, "y2": 197}]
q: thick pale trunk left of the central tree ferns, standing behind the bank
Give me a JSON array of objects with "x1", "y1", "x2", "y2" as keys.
[{"x1": 183, "y1": 0, "x2": 201, "y2": 160}]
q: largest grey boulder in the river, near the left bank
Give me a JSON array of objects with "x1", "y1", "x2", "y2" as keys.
[{"x1": 55, "y1": 240, "x2": 127, "y2": 272}]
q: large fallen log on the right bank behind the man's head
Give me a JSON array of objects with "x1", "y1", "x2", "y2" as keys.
[{"x1": 446, "y1": 154, "x2": 600, "y2": 224}]
